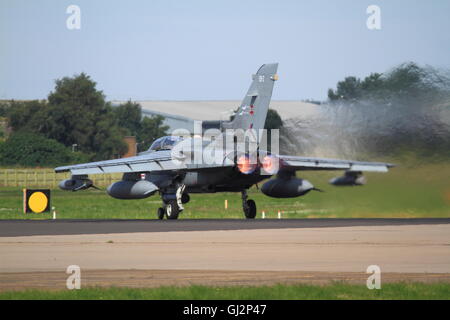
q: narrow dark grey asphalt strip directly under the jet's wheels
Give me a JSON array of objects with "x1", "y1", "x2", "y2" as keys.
[{"x1": 0, "y1": 218, "x2": 450, "y2": 237}]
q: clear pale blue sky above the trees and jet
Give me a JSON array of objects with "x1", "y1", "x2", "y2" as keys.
[{"x1": 0, "y1": 0, "x2": 450, "y2": 100}]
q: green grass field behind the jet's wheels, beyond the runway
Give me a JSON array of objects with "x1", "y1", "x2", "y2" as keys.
[{"x1": 0, "y1": 164, "x2": 450, "y2": 219}]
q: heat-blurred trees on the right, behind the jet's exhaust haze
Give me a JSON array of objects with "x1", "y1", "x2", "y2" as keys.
[{"x1": 327, "y1": 62, "x2": 450, "y2": 158}]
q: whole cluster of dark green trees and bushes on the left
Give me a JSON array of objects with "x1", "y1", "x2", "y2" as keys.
[{"x1": 0, "y1": 73, "x2": 168, "y2": 166}]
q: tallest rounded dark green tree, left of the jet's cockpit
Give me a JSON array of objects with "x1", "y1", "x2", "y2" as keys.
[{"x1": 41, "y1": 73, "x2": 127, "y2": 160}]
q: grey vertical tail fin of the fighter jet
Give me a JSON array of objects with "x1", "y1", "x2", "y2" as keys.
[{"x1": 223, "y1": 63, "x2": 278, "y2": 130}]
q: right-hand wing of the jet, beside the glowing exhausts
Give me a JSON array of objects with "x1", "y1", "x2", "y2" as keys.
[{"x1": 279, "y1": 155, "x2": 394, "y2": 172}]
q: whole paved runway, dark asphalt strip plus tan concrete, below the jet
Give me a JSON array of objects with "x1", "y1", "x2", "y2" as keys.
[{"x1": 0, "y1": 219, "x2": 450, "y2": 290}]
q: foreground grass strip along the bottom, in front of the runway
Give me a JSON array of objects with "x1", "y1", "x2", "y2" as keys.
[{"x1": 0, "y1": 283, "x2": 450, "y2": 300}]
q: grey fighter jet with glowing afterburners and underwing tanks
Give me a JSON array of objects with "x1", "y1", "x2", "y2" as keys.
[{"x1": 55, "y1": 63, "x2": 393, "y2": 219}]
